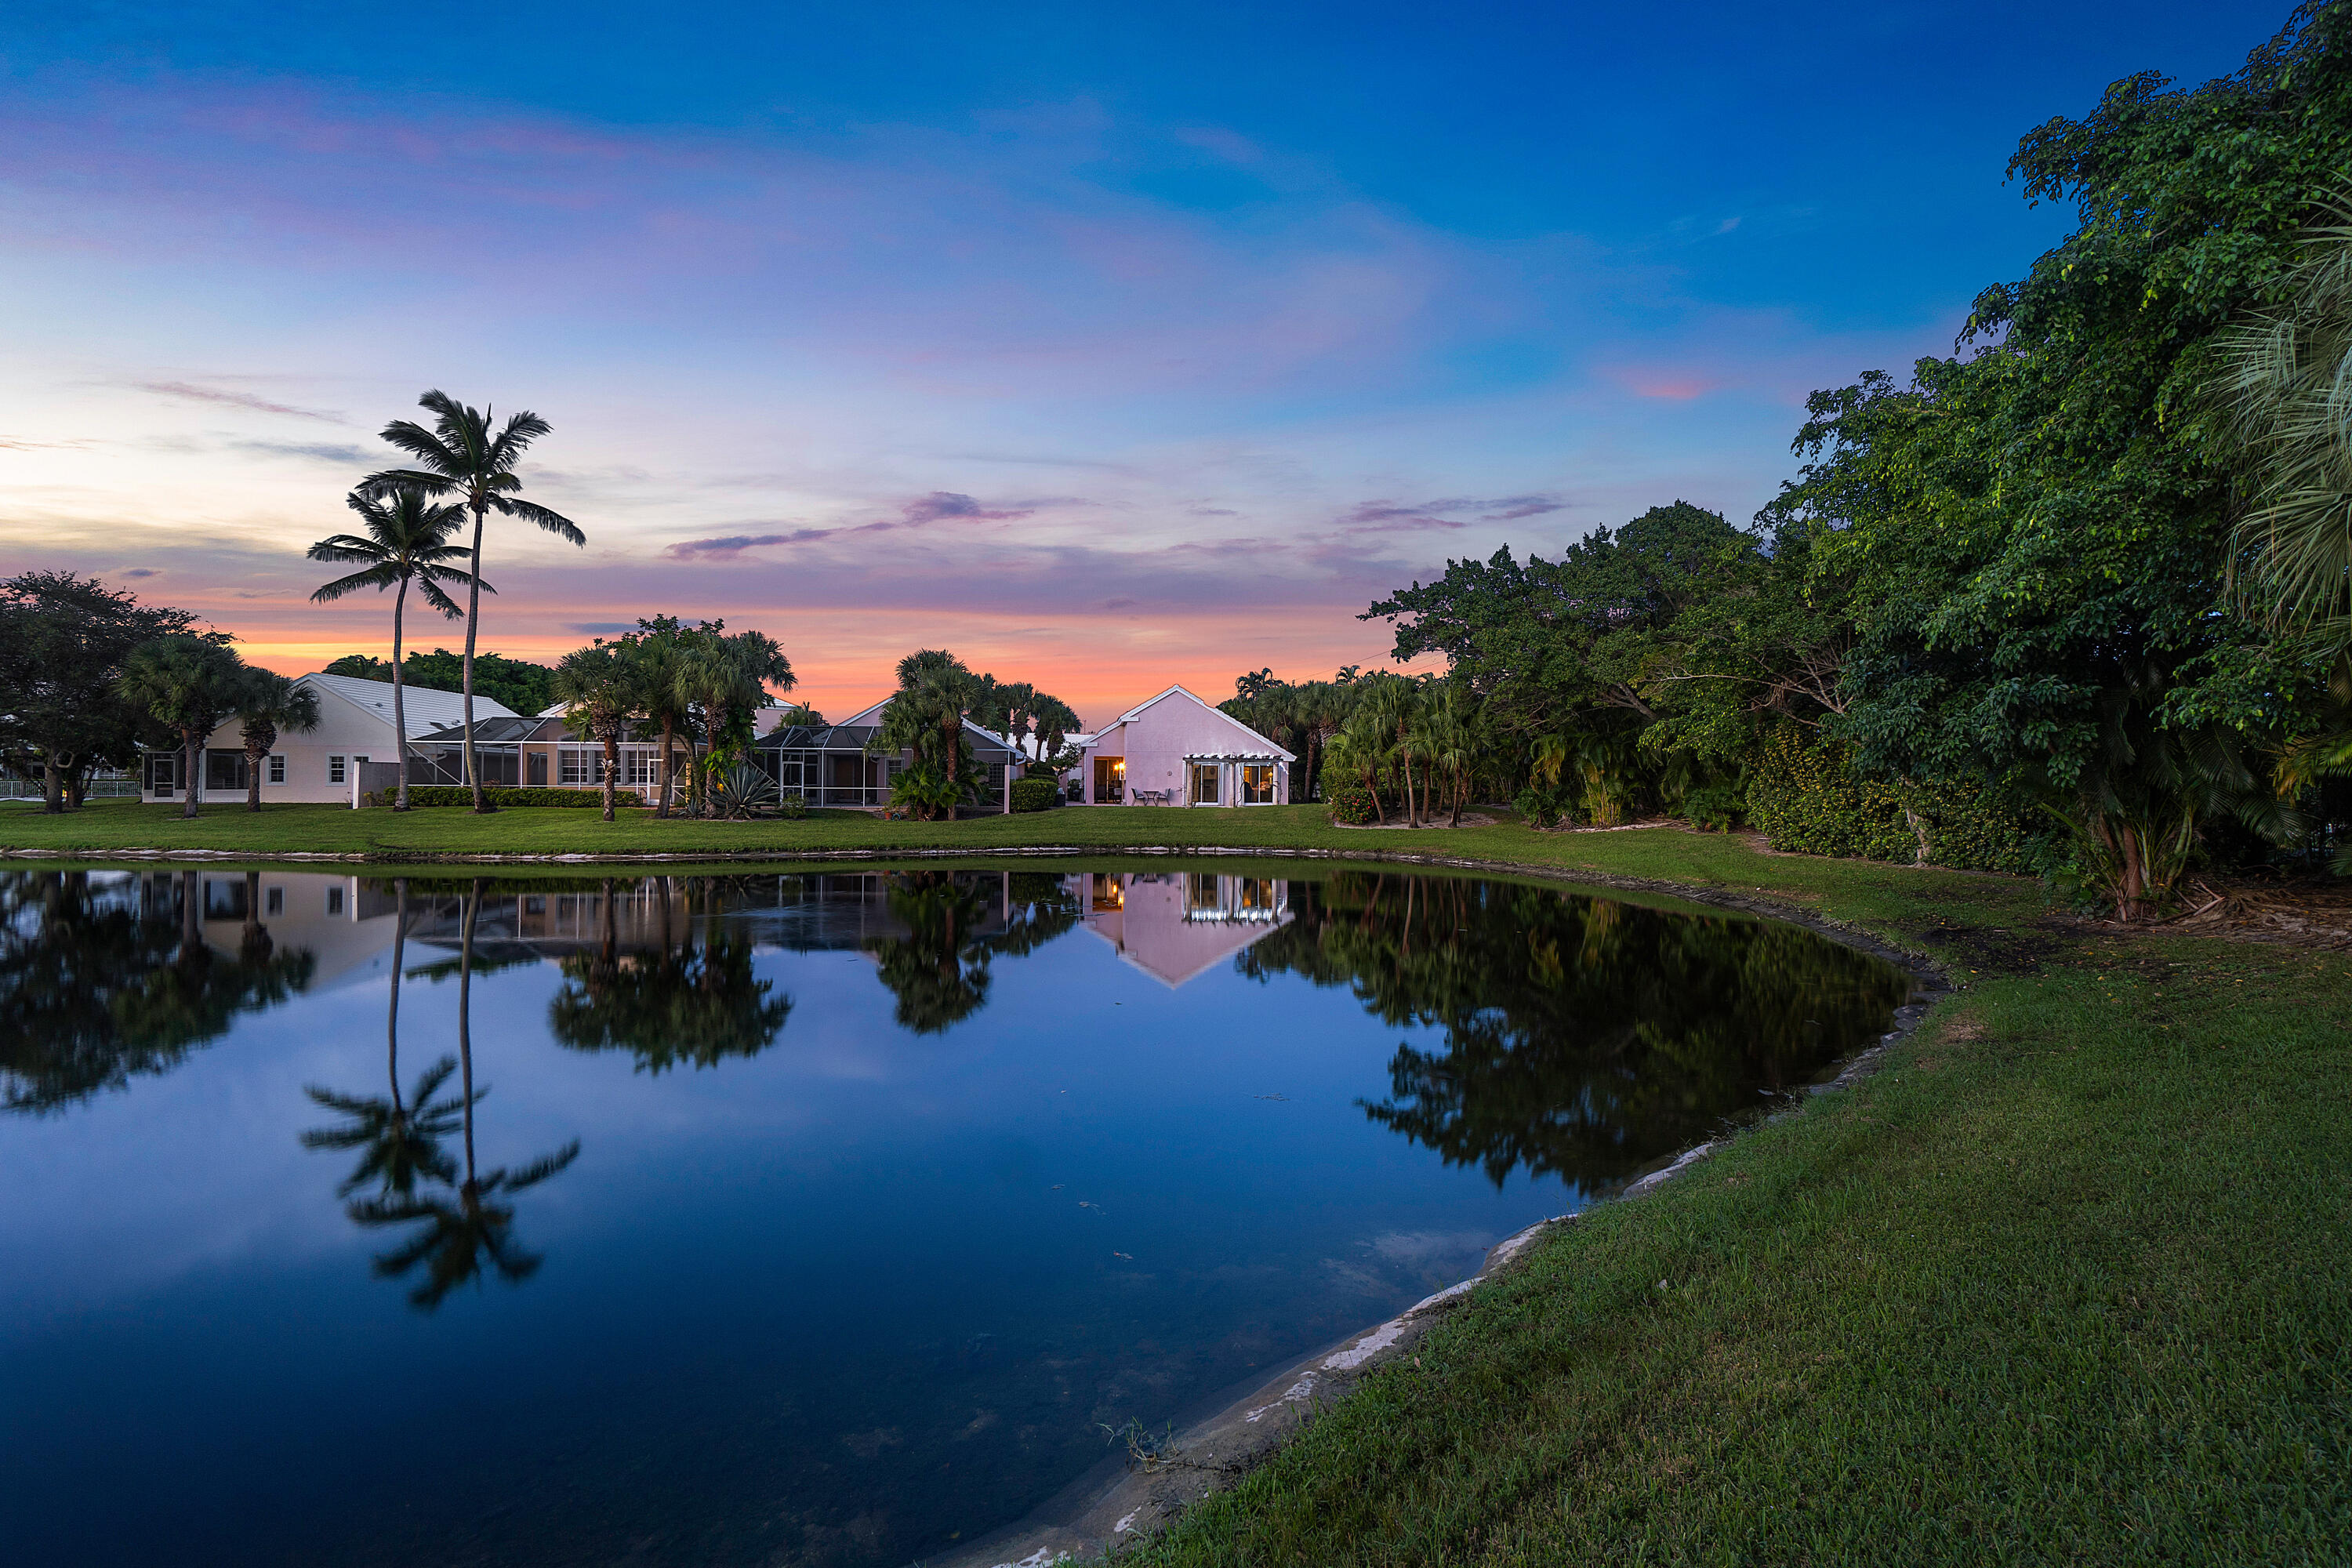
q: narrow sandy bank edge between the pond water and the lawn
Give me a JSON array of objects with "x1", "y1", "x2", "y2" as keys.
[{"x1": 0, "y1": 844, "x2": 1952, "y2": 1568}]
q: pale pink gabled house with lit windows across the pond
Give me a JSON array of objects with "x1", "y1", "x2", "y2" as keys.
[{"x1": 1077, "y1": 687, "x2": 1296, "y2": 806}]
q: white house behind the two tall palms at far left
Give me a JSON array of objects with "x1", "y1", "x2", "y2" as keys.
[{"x1": 141, "y1": 675, "x2": 517, "y2": 801}]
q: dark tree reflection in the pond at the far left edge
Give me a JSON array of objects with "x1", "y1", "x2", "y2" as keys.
[{"x1": 0, "y1": 872, "x2": 315, "y2": 1114}]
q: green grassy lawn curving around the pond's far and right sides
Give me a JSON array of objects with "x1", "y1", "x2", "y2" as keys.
[{"x1": 0, "y1": 804, "x2": 2352, "y2": 1566}]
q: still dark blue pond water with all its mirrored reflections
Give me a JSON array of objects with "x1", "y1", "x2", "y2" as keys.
[{"x1": 0, "y1": 860, "x2": 1907, "y2": 1568}]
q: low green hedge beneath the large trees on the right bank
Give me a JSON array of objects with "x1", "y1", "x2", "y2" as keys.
[{"x1": 1748, "y1": 727, "x2": 2056, "y2": 872}]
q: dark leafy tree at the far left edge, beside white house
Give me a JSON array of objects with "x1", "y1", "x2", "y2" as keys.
[{"x1": 0, "y1": 572, "x2": 198, "y2": 813}]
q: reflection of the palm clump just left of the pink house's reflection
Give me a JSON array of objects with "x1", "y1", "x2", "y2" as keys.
[{"x1": 866, "y1": 869, "x2": 1080, "y2": 1034}]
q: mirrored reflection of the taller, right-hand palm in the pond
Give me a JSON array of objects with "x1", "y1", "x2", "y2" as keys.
[{"x1": 348, "y1": 881, "x2": 581, "y2": 1312}]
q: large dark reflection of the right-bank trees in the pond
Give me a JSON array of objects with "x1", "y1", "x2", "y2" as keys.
[{"x1": 1240, "y1": 872, "x2": 1910, "y2": 1185}]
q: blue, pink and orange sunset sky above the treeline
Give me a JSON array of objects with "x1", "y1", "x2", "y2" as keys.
[{"x1": 0, "y1": 0, "x2": 2288, "y2": 722}]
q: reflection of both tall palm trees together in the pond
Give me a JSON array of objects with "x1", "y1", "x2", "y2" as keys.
[{"x1": 303, "y1": 881, "x2": 581, "y2": 1312}]
